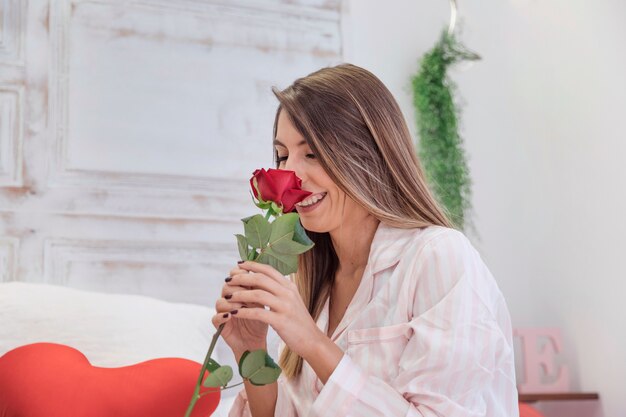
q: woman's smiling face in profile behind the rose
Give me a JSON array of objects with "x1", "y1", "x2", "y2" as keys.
[{"x1": 274, "y1": 111, "x2": 360, "y2": 233}]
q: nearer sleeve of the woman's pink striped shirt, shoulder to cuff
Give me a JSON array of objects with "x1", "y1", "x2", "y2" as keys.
[{"x1": 312, "y1": 232, "x2": 519, "y2": 417}]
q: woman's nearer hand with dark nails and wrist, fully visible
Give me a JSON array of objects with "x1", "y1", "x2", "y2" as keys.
[{"x1": 218, "y1": 261, "x2": 325, "y2": 358}]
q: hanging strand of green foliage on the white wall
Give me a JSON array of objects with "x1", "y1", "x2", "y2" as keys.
[{"x1": 412, "y1": 32, "x2": 478, "y2": 229}]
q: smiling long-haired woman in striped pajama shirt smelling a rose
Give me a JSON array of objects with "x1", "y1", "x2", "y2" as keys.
[{"x1": 213, "y1": 64, "x2": 518, "y2": 417}]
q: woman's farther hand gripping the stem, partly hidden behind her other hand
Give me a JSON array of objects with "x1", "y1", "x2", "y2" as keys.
[{"x1": 212, "y1": 267, "x2": 267, "y2": 361}]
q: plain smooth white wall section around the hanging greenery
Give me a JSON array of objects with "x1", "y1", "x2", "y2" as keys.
[{"x1": 343, "y1": 0, "x2": 626, "y2": 416}]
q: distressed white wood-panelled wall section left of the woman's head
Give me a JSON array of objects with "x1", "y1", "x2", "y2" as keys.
[{"x1": 0, "y1": 0, "x2": 341, "y2": 306}]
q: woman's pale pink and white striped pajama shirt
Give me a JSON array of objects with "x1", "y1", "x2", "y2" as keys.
[{"x1": 229, "y1": 223, "x2": 519, "y2": 417}]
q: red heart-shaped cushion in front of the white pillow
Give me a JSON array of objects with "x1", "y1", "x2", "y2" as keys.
[{"x1": 0, "y1": 343, "x2": 220, "y2": 417}]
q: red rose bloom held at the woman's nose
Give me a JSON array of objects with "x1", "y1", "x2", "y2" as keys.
[{"x1": 250, "y1": 168, "x2": 313, "y2": 213}]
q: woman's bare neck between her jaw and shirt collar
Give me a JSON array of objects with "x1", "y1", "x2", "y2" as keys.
[{"x1": 330, "y1": 214, "x2": 380, "y2": 279}]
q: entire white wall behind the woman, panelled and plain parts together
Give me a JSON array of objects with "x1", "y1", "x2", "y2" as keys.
[{"x1": 0, "y1": 0, "x2": 626, "y2": 416}]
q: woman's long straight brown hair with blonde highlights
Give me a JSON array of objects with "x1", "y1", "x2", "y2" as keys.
[{"x1": 272, "y1": 64, "x2": 452, "y2": 378}]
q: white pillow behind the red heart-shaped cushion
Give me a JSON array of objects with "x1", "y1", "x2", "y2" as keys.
[{"x1": 0, "y1": 282, "x2": 219, "y2": 367}]
